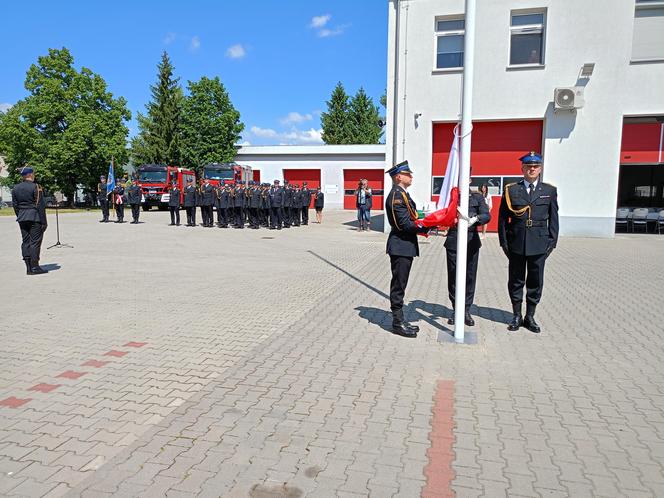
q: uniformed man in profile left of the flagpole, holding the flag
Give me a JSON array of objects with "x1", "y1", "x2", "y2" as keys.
[{"x1": 385, "y1": 161, "x2": 429, "y2": 337}]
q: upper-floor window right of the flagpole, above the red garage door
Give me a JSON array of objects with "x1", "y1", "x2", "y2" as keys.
[{"x1": 510, "y1": 12, "x2": 545, "y2": 66}]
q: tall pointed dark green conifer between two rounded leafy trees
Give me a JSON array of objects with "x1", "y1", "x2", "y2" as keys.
[{"x1": 131, "y1": 51, "x2": 184, "y2": 165}]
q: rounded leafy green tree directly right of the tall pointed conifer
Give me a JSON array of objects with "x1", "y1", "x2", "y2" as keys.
[{"x1": 182, "y1": 76, "x2": 244, "y2": 172}]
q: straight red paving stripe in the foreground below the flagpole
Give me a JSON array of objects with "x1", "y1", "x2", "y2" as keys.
[{"x1": 422, "y1": 380, "x2": 454, "y2": 498}]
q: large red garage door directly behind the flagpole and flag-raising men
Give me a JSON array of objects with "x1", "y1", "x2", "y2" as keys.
[{"x1": 431, "y1": 120, "x2": 544, "y2": 231}]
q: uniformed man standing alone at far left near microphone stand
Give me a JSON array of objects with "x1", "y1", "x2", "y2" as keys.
[{"x1": 12, "y1": 166, "x2": 48, "y2": 275}]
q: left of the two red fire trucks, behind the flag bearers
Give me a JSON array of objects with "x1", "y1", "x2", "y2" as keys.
[{"x1": 138, "y1": 164, "x2": 196, "y2": 211}]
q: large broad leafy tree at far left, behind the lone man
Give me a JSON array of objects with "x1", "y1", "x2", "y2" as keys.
[{"x1": 0, "y1": 48, "x2": 131, "y2": 202}]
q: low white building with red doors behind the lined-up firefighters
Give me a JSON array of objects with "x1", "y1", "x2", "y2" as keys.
[{"x1": 235, "y1": 145, "x2": 385, "y2": 209}]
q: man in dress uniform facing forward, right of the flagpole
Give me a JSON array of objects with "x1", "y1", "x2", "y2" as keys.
[{"x1": 498, "y1": 152, "x2": 558, "y2": 334}]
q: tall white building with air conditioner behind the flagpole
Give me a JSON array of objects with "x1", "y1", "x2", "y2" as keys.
[{"x1": 386, "y1": 0, "x2": 664, "y2": 237}]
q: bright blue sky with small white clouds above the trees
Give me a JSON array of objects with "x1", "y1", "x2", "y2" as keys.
[{"x1": 0, "y1": 0, "x2": 388, "y2": 145}]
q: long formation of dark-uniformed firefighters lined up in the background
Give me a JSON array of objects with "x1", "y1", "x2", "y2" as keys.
[{"x1": 98, "y1": 176, "x2": 324, "y2": 230}]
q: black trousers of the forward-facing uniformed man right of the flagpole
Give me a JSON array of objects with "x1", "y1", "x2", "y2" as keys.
[{"x1": 507, "y1": 252, "x2": 546, "y2": 312}]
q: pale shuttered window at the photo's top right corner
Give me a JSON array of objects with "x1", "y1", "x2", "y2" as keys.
[{"x1": 632, "y1": 0, "x2": 664, "y2": 61}]
